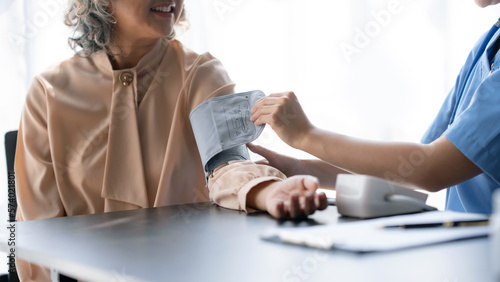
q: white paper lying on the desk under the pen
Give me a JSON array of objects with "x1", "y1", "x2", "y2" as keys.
[{"x1": 262, "y1": 211, "x2": 490, "y2": 252}]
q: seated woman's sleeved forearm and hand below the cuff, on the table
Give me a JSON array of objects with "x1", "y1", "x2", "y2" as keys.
[{"x1": 208, "y1": 161, "x2": 327, "y2": 218}]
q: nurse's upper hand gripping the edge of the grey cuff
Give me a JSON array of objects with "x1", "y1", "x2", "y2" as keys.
[{"x1": 250, "y1": 92, "x2": 314, "y2": 148}]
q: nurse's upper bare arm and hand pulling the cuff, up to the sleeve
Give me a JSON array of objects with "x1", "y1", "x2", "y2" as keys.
[{"x1": 251, "y1": 92, "x2": 481, "y2": 191}]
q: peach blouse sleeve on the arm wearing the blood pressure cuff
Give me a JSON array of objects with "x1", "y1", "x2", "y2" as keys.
[{"x1": 188, "y1": 54, "x2": 286, "y2": 212}]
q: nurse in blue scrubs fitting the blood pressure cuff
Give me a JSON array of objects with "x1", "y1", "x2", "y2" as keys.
[{"x1": 248, "y1": 0, "x2": 500, "y2": 214}]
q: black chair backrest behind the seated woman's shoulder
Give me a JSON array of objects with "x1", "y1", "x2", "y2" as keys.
[{"x1": 5, "y1": 130, "x2": 17, "y2": 222}]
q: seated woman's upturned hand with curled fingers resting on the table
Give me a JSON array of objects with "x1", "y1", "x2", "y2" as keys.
[{"x1": 247, "y1": 175, "x2": 328, "y2": 219}]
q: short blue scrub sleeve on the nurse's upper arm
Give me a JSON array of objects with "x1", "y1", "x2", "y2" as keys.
[{"x1": 444, "y1": 71, "x2": 500, "y2": 184}]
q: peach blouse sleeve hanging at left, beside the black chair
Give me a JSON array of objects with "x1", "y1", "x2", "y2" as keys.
[{"x1": 15, "y1": 78, "x2": 64, "y2": 281}]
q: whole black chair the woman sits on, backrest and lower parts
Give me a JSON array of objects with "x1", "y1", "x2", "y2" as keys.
[{"x1": 4, "y1": 130, "x2": 77, "y2": 282}]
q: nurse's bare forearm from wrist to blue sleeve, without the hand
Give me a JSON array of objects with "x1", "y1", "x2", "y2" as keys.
[{"x1": 297, "y1": 127, "x2": 481, "y2": 192}]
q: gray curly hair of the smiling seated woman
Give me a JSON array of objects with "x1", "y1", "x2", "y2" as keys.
[{"x1": 64, "y1": 0, "x2": 188, "y2": 57}]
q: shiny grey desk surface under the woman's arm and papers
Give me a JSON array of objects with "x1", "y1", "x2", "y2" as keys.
[{"x1": 1, "y1": 203, "x2": 493, "y2": 282}]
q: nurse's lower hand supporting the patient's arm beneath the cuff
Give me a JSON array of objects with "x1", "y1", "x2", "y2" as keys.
[{"x1": 247, "y1": 143, "x2": 304, "y2": 177}]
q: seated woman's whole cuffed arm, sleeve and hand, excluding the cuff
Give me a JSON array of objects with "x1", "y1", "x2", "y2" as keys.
[{"x1": 185, "y1": 57, "x2": 327, "y2": 218}]
